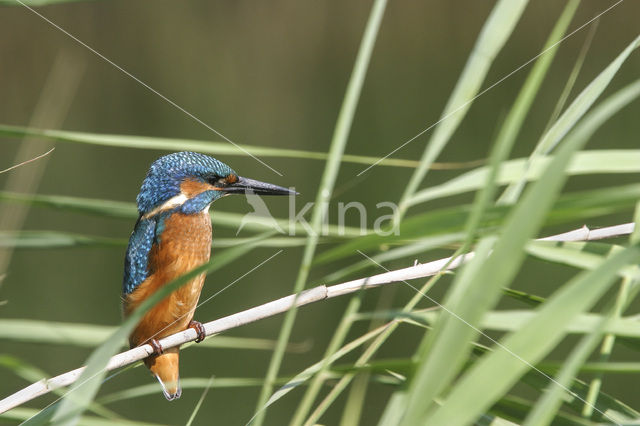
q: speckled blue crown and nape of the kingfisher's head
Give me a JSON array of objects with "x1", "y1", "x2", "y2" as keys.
[{"x1": 137, "y1": 152, "x2": 236, "y2": 214}]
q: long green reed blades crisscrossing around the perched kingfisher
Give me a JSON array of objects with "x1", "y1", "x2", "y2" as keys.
[{"x1": 0, "y1": 0, "x2": 640, "y2": 426}]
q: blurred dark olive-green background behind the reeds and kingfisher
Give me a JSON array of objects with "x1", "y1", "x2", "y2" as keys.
[{"x1": 0, "y1": 0, "x2": 640, "y2": 425}]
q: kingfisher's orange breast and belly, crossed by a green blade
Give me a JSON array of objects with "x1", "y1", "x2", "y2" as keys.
[{"x1": 124, "y1": 212, "x2": 211, "y2": 347}]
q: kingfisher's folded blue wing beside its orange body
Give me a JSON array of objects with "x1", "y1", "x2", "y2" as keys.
[{"x1": 122, "y1": 217, "x2": 157, "y2": 295}]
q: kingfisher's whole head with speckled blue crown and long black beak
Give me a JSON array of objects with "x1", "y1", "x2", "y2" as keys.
[{"x1": 137, "y1": 152, "x2": 295, "y2": 216}]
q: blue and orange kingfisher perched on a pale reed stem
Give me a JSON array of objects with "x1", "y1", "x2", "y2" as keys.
[{"x1": 122, "y1": 152, "x2": 297, "y2": 401}]
